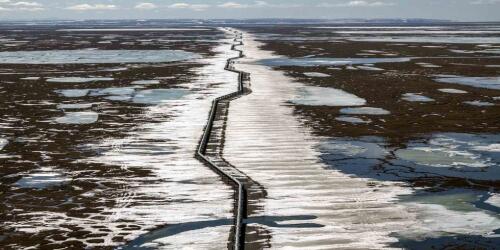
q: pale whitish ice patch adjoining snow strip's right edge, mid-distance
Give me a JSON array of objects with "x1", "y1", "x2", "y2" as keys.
[{"x1": 291, "y1": 87, "x2": 366, "y2": 106}]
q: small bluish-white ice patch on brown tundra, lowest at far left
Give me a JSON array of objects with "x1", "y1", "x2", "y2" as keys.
[{"x1": 15, "y1": 168, "x2": 70, "y2": 189}]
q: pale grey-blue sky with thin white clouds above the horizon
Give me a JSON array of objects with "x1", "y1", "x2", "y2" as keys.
[{"x1": 0, "y1": 0, "x2": 500, "y2": 21}]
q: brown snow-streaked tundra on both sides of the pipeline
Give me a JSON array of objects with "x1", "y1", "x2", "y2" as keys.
[{"x1": 0, "y1": 21, "x2": 500, "y2": 249}]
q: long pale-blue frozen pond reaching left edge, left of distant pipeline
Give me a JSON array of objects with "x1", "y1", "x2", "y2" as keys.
[{"x1": 0, "y1": 50, "x2": 200, "y2": 64}]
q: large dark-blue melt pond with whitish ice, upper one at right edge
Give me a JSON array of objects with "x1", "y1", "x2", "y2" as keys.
[{"x1": 320, "y1": 133, "x2": 500, "y2": 180}]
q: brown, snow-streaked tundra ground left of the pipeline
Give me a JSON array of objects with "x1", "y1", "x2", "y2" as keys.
[{"x1": 0, "y1": 21, "x2": 236, "y2": 249}]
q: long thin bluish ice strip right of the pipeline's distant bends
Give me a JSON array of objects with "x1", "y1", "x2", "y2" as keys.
[{"x1": 257, "y1": 57, "x2": 411, "y2": 67}]
